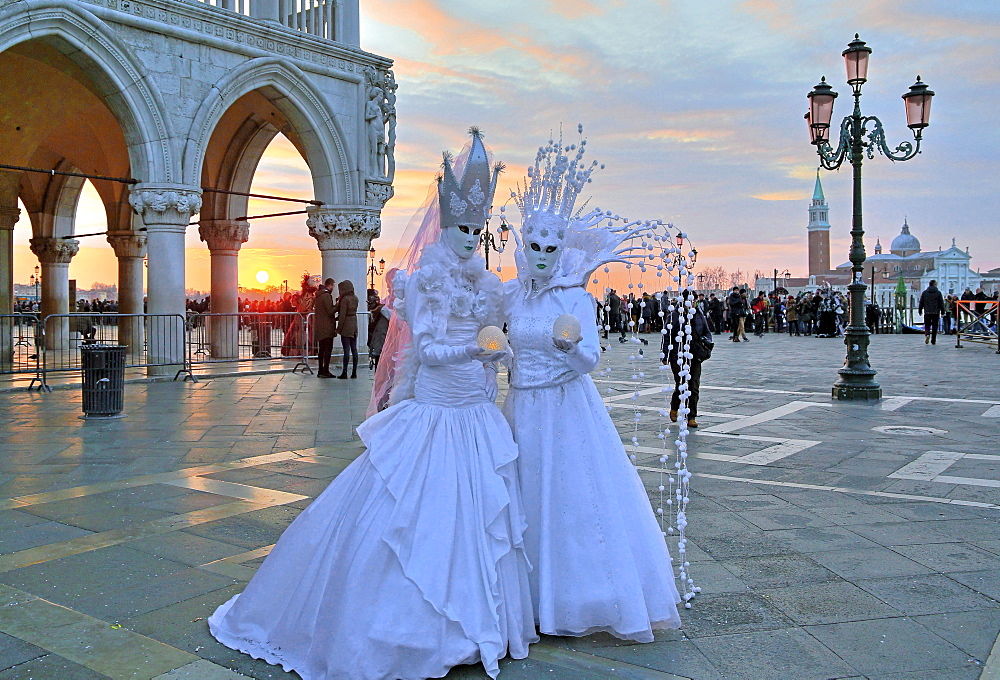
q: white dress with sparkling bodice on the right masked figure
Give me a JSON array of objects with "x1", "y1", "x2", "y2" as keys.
[{"x1": 503, "y1": 280, "x2": 680, "y2": 642}]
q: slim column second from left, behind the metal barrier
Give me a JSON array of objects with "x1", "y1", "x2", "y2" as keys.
[{"x1": 29, "y1": 236, "x2": 80, "y2": 354}]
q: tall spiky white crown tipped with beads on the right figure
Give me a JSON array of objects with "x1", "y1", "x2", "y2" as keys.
[{"x1": 511, "y1": 125, "x2": 604, "y2": 244}]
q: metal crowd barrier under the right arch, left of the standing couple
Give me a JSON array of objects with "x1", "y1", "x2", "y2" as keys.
[{"x1": 187, "y1": 312, "x2": 312, "y2": 373}]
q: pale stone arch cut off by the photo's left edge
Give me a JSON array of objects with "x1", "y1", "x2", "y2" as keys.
[{"x1": 0, "y1": 0, "x2": 178, "y2": 182}]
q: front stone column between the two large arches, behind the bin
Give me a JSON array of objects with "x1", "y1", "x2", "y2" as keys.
[{"x1": 129, "y1": 184, "x2": 201, "y2": 375}]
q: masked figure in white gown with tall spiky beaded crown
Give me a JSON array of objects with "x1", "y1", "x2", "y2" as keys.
[{"x1": 504, "y1": 131, "x2": 680, "y2": 642}]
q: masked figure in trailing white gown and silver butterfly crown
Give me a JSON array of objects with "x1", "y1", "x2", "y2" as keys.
[{"x1": 209, "y1": 131, "x2": 537, "y2": 680}]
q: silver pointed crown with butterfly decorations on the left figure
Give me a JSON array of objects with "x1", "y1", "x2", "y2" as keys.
[{"x1": 438, "y1": 127, "x2": 504, "y2": 229}]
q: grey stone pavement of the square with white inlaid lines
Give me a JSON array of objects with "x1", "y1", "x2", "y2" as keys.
[{"x1": 0, "y1": 335, "x2": 1000, "y2": 680}]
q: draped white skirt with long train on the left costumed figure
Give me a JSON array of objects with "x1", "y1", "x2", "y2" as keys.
[{"x1": 209, "y1": 400, "x2": 537, "y2": 680}]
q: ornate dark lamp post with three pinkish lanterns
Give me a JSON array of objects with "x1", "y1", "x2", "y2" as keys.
[{"x1": 805, "y1": 35, "x2": 934, "y2": 400}]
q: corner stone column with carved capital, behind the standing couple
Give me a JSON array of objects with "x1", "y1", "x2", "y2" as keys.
[{"x1": 306, "y1": 206, "x2": 382, "y2": 352}]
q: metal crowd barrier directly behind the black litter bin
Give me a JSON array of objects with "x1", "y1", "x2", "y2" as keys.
[{"x1": 28, "y1": 312, "x2": 195, "y2": 391}]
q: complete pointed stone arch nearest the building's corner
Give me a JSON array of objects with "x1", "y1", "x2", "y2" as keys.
[{"x1": 184, "y1": 57, "x2": 359, "y2": 204}]
